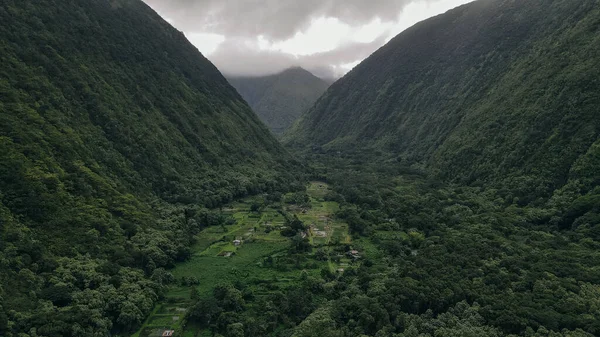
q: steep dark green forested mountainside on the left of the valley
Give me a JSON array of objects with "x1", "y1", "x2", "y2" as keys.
[{"x1": 0, "y1": 0, "x2": 293, "y2": 336}]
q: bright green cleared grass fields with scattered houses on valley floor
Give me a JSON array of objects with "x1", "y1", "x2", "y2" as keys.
[{"x1": 134, "y1": 182, "x2": 352, "y2": 337}]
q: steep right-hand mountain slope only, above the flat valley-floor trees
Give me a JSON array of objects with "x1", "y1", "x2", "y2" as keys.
[{"x1": 286, "y1": 0, "x2": 600, "y2": 198}]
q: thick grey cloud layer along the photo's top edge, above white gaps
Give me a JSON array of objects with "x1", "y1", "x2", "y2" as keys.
[{"x1": 145, "y1": 0, "x2": 418, "y2": 41}]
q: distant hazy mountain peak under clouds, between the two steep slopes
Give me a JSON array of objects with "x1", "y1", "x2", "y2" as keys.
[{"x1": 228, "y1": 68, "x2": 329, "y2": 134}]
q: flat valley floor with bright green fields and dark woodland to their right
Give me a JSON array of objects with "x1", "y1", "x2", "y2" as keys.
[{"x1": 124, "y1": 158, "x2": 600, "y2": 337}]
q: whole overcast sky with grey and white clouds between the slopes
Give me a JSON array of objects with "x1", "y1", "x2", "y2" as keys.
[{"x1": 144, "y1": 0, "x2": 472, "y2": 78}]
